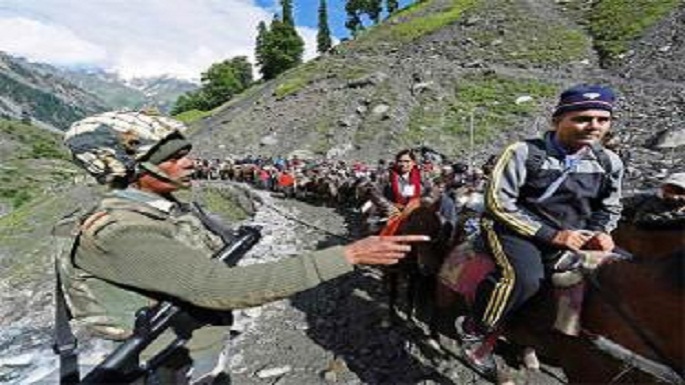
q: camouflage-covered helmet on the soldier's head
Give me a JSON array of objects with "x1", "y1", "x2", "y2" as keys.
[{"x1": 64, "y1": 111, "x2": 191, "y2": 185}]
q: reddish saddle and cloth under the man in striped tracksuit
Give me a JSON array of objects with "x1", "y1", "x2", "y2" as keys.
[{"x1": 438, "y1": 240, "x2": 627, "y2": 336}]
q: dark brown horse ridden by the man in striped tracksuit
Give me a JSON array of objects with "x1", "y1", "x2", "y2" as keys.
[{"x1": 437, "y1": 220, "x2": 685, "y2": 383}]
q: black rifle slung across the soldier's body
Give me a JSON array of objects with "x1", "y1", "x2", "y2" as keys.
[{"x1": 80, "y1": 226, "x2": 261, "y2": 385}]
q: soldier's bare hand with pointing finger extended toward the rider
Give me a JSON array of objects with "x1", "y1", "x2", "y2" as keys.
[{"x1": 344, "y1": 235, "x2": 430, "y2": 265}]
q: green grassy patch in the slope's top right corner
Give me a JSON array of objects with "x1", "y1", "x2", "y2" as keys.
[{"x1": 588, "y1": 0, "x2": 682, "y2": 61}]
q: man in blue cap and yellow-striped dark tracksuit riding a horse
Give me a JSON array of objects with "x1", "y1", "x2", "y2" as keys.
[{"x1": 457, "y1": 85, "x2": 623, "y2": 374}]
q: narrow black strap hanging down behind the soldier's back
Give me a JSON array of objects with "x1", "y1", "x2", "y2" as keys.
[{"x1": 52, "y1": 261, "x2": 81, "y2": 385}]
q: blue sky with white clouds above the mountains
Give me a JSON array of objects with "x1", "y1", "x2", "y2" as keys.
[{"x1": 0, "y1": 0, "x2": 358, "y2": 80}]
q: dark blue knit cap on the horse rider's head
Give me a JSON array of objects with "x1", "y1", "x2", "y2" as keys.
[{"x1": 552, "y1": 84, "x2": 616, "y2": 116}]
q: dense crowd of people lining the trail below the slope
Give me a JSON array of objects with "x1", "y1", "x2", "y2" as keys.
[{"x1": 193, "y1": 149, "x2": 494, "y2": 208}]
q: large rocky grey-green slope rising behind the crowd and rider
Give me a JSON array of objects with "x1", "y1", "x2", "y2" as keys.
[{"x1": 190, "y1": 0, "x2": 685, "y2": 187}]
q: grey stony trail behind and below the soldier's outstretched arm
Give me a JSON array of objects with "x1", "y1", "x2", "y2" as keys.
[{"x1": 0, "y1": 181, "x2": 560, "y2": 385}]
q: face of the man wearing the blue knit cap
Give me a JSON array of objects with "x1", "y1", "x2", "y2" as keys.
[{"x1": 555, "y1": 110, "x2": 611, "y2": 151}]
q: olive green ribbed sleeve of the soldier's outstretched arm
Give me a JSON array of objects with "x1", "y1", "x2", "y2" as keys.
[{"x1": 75, "y1": 224, "x2": 353, "y2": 310}]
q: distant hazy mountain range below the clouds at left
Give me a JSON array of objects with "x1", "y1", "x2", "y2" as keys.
[{"x1": 0, "y1": 52, "x2": 198, "y2": 130}]
